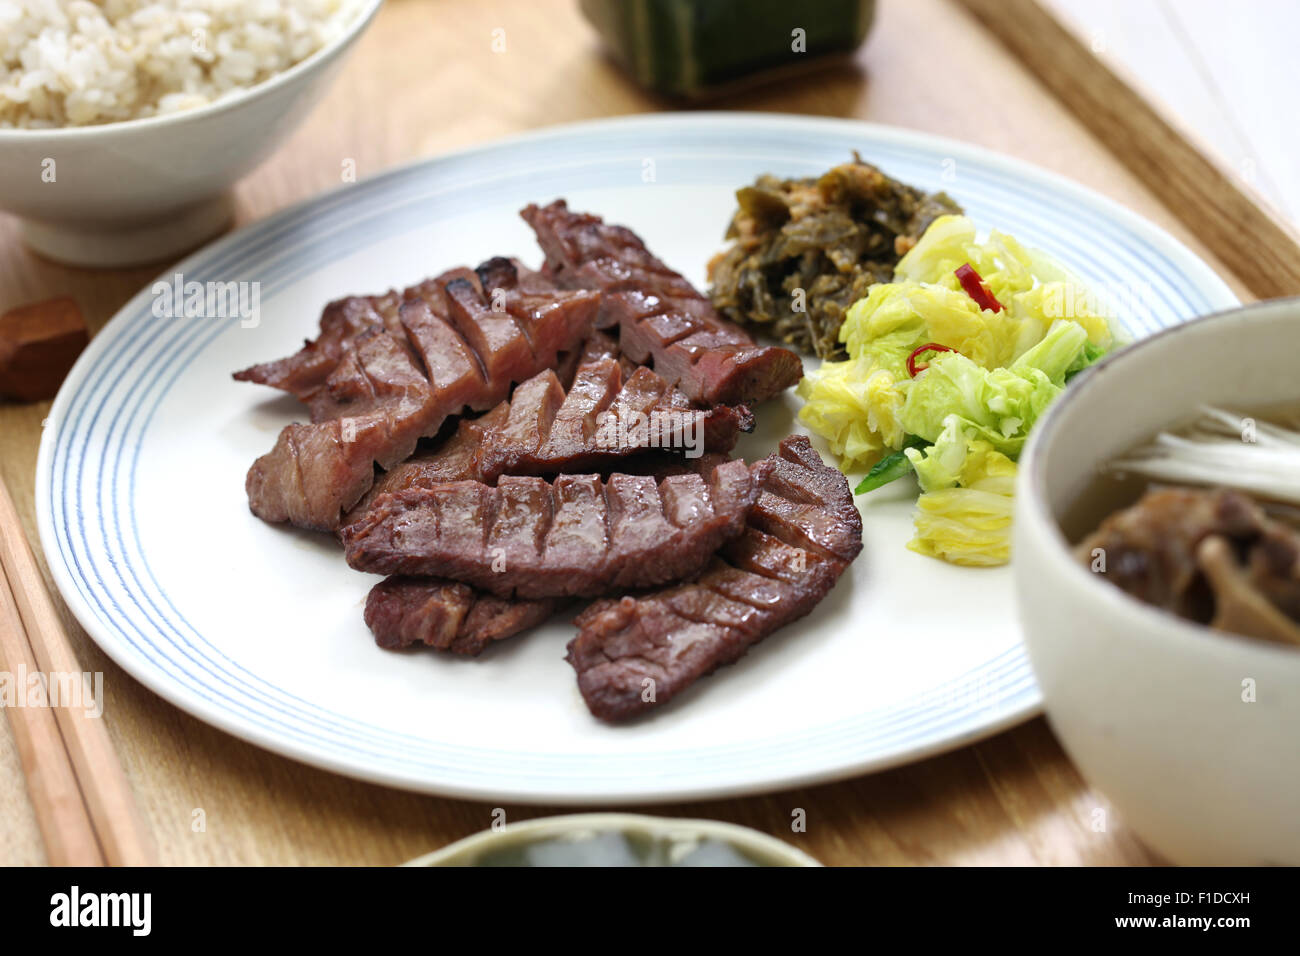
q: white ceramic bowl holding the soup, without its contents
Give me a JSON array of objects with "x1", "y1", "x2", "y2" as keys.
[{"x1": 1013, "y1": 299, "x2": 1300, "y2": 865}]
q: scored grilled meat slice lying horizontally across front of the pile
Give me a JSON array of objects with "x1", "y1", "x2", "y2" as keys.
[{"x1": 341, "y1": 462, "x2": 771, "y2": 597}]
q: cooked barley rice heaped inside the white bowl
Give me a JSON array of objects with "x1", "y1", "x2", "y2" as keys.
[{"x1": 0, "y1": 0, "x2": 363, "y2": 129}]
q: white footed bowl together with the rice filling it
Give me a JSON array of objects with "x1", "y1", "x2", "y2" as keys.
[{"x1": 0, "y1": 0, "x2": 382, "y2": 267}]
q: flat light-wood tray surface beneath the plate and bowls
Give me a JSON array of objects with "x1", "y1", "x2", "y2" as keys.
[{"x1": 0, "y1": 0, "x2": 1240, "y2": 864}]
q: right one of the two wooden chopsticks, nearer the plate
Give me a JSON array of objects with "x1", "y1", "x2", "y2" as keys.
[{"x1": 0, "y1": 480, "x2": 155, "y2": 866}]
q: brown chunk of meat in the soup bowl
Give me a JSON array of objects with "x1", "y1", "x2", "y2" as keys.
[{"x1": 1075, "y1": 488, "x2": 1300, "y2": 644}]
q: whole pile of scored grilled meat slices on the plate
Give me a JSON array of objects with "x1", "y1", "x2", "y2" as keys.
[{"x1": 235, "y1": 200, "x2": 861, "y2": 721}]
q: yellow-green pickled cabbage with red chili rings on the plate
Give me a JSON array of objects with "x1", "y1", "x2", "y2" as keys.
[{"x1": 798, "y1": 216, "x2": 1117, "y2": 564}]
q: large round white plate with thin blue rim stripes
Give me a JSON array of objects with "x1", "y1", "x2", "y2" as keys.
[{"x1": 36, "y1": 113, "x2": 1235, "y2": 804}]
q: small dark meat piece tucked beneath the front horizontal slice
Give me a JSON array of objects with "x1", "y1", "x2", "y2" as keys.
[{"x1": 365, "y1": 578, "x2": 559, "y2": 657}]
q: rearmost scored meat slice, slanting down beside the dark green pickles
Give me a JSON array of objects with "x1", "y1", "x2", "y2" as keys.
[{"x1": 523, "y1": 199, "x2": 803, "y2": 406}]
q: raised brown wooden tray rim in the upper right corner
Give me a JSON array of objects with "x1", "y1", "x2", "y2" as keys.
[{"x1": 961, "y1": 0, "x2": 1300, "y2": 298}]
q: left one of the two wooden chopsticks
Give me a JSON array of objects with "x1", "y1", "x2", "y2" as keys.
[{"x1": 0, "y1": 561, "x2": 104, "y2": 866}]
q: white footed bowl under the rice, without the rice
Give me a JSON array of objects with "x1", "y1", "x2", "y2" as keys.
[{"x1": 0, "y1": 0, "x2": 382, "y2": 267}]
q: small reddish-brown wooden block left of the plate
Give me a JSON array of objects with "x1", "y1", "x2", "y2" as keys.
[{"x1": 0, "y1": 295, "x2": 90, "y2": 402}]
